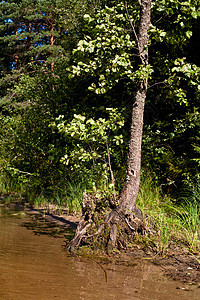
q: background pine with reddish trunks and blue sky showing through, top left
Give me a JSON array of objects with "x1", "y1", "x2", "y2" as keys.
[{"x1": 0, "y1": 0, "x2": 91, "y2": 107}]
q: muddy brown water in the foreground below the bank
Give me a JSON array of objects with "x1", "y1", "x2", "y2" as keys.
[{"x1": 0, "y1": 206, "x2": 200, "y2": 300}]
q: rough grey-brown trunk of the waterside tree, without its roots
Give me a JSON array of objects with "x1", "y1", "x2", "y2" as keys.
[{"x1": 120, "y1": 0, "x2": 151, "y2": 215}]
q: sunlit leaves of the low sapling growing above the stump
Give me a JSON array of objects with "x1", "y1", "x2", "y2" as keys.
[{"x1": 52, "y1": 107, "x2": 124, "y2": 184}]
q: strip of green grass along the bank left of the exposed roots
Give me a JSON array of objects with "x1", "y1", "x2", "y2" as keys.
[{"x1": 0, "y1": 166, "x2": 85, "y2": 214}]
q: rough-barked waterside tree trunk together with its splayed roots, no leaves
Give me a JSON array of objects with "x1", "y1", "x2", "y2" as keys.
[{"x1": 67, "y1": 0, "x2": 151, "y2": 252}]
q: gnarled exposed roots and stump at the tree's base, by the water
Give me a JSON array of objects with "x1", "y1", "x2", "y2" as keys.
[{"x1": 66, "y1": 192, "x2": 152, "y2": 253}]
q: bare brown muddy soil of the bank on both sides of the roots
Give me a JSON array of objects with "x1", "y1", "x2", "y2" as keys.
[{"x1": 1, "y1": 204, "x2": 200, "y2": 288}]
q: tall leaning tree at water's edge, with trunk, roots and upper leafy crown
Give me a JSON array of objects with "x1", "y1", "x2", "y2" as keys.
[{"x1": 62, "y1": 0, "x2": 199, "y2": 251}]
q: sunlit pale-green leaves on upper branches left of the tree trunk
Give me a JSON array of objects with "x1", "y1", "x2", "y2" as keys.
[{"x1": 68, "y1": 2, "x2": 153, "y2": 94}]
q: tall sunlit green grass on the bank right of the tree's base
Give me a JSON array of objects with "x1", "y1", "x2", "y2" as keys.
[{"x1": 138, "y1": 176, "x2": 200, "y2": 255}]
